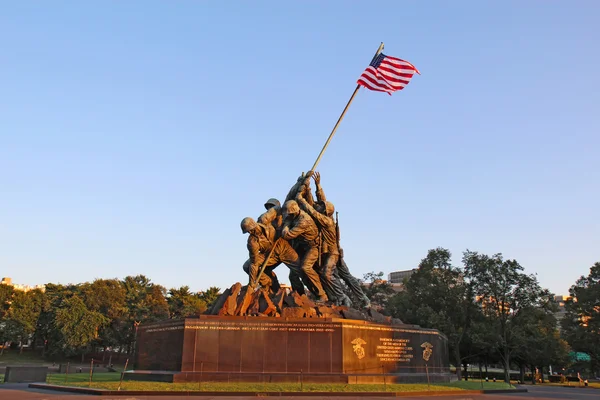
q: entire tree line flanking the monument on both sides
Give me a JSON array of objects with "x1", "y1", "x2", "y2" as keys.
[{"x1": 0, "y1": 248, "x2": 600, "y2": 381}]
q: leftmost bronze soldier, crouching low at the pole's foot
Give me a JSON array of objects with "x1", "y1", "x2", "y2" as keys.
[{"x1": 240, "y1": 217, "x2": 299, "y2": 292}]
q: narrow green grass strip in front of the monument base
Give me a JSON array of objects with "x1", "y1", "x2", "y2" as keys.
[{"x1": 48, "y1": 372, "x2": 507, "y2": 392}]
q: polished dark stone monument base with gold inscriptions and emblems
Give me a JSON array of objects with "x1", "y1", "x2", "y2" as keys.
[{"x1": 125, "y1": 316, "x2": 454, "y2": 384}]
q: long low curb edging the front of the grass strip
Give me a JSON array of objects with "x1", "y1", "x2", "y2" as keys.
[{"x1": 29, "y1": 383, "x2": 527, "y2": 397}]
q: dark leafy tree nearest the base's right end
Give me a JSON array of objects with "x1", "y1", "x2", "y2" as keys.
[{"x1": 388, "y1": 247, "x2": 477, "y2": 379}]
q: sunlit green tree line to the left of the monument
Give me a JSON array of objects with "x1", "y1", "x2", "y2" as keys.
[{"x1": 0, "y1": 275, "x2": 220, "y2": 360}]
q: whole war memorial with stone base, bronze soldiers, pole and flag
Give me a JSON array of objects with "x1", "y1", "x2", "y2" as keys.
[{"x1": 130, "y1": 43, "x2": 452, "y2": 383}]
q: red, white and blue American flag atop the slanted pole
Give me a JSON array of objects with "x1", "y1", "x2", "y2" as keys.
[{"x1": 356, "y1": 53, "x2": 421, "y2": 95}]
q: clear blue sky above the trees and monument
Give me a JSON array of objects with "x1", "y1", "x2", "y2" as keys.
[{"x1": 0, "y1": 0, "x2": 600, "y2": 294}]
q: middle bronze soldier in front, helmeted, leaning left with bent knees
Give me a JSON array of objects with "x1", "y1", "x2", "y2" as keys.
[{"x1": 281, "y1": 200, "x2": 328, "y2": 301}]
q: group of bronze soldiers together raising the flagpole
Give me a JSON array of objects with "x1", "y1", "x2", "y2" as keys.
[{"x1": 241, "y1": 171, "x2": 370, "y2": 307}]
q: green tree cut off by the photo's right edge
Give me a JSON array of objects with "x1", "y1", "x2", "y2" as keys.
[{"x1": 561, "y1": 262, "x2": 600, "y2": 372}]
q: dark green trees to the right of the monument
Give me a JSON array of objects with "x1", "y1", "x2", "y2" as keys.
[{"x1": 365, "y1": 248, "x2": 600, "y2": 381}]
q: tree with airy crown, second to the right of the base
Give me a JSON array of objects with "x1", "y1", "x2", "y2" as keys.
[{"x1": 463, "y1": 250, "x2": 551, "y2": 382}]
